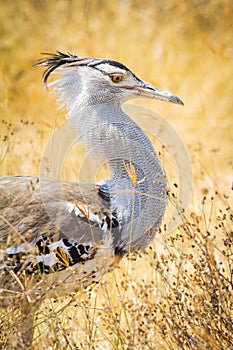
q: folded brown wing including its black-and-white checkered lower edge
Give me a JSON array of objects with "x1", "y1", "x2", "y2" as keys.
[{"x1": 0, "y1": 177, "x2": 118, "y2": 272}]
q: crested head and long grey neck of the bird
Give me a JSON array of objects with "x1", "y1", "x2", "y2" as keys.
[{"x1": 35, "y1": 53, "x2": 181, "y2": 252}]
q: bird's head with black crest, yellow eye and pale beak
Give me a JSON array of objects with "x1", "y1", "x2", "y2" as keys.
[{"x1": 36, "y1": 52, "x2": 183, "y2": 109}]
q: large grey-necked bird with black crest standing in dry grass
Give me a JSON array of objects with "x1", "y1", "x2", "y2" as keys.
[{"x1": 0, "y1": 51, "x2": 183, "y2": 348}]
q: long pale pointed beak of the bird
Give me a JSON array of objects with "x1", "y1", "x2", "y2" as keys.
[{"x1": 134, "y1": 81, "x2": 184, "y2": 105}]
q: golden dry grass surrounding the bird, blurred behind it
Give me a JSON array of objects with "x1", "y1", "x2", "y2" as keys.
[{"x1": 0, "y1": 0, "x2": 233, "y2": 350}]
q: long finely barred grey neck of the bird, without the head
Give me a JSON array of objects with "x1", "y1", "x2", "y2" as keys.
[{"x1": 66, "y1": 96, "x2": 167, "y2": 249}]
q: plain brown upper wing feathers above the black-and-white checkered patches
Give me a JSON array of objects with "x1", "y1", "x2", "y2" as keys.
[{"x1": 0, "y1": 176, "x2": 110, "y2": 249}]
